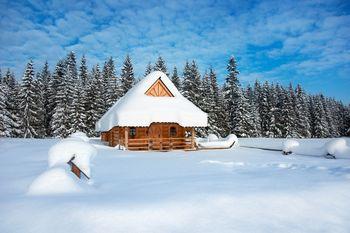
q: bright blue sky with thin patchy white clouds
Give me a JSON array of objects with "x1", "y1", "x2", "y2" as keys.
[{"x1": 0, "y1": 0, "x2": 350, "y2": 103}]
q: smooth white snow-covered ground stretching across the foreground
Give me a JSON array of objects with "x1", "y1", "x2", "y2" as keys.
[{"x1": 0, "y1": 139, "x2": 350, "y2": 233}]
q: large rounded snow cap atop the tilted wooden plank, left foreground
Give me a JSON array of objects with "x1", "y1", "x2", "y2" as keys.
[{"x1": 49, "y1": 138, "x2": 97, "y2": 177}]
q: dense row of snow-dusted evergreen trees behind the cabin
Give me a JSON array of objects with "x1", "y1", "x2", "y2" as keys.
[{"x1": 0, "y1": 52, "x2": 350, "y2": 138}]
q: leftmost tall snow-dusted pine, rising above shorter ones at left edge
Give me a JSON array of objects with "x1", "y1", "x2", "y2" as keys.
[{"x1": 20, "y1": 60, "x2": 38, "y2": 138}]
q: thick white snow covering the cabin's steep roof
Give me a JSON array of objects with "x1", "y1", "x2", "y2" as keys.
[{"x1": 96, "y1": 71, "x2": 208, "y2": 131}]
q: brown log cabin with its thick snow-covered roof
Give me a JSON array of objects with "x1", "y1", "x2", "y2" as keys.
[{"x1": 96, "y1": 71, "x2": 208, "y2": 150}]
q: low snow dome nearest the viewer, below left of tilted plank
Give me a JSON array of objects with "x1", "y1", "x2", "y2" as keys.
[{"x1": 28, "y1": 167, "x2": 81, "y2": 195}]
